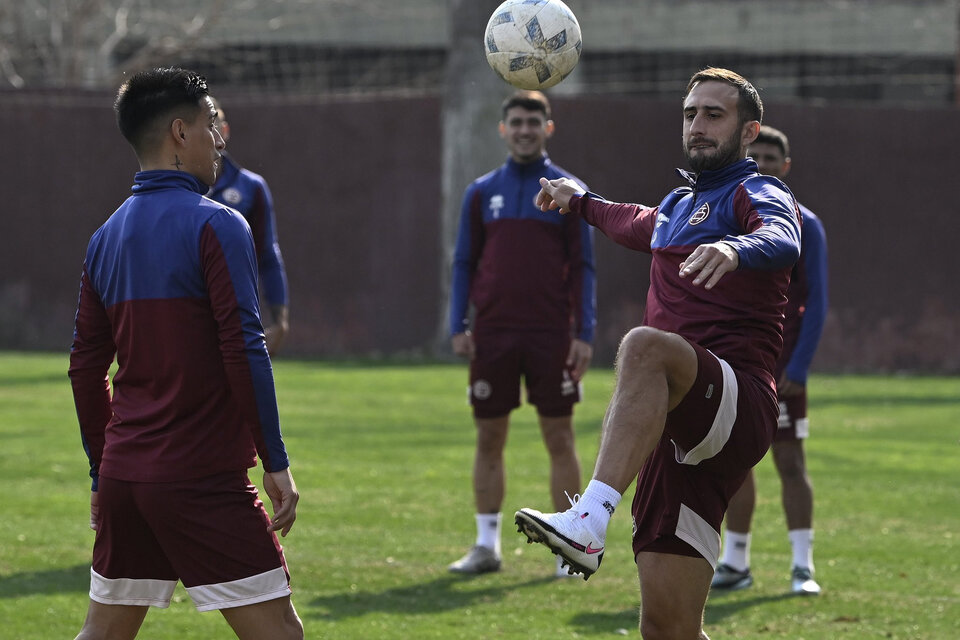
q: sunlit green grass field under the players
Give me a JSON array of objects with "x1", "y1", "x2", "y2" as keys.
[{"x1": 0, "y1": 353, "x2": 960, "y2": 640}]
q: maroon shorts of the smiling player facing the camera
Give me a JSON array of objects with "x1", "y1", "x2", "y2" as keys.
[{"x1": 469, "y1": 331, "x2": 580, "y2": 418}]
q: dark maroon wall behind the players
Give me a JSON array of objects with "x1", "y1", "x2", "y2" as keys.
[{"x1": 0, "y1": 92, "x2": 960, "y2": 373}]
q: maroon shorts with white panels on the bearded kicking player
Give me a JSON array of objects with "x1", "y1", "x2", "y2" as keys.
[{"x1": 633, "y1": 343, "x2": 777, "y2": 566}]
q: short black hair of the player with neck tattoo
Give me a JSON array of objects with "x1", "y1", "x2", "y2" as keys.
[{"x1": 113, "y1": 68, "x2": 207, "y2": 154}]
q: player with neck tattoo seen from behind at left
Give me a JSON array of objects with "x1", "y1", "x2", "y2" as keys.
[{"x1": 69, "y1": 69, "x2": 303, "y2": 640}]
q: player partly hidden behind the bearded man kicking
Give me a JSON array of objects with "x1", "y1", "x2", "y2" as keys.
[{"x1": 712, "y1": 126, "x2": 827, "y2": 595}]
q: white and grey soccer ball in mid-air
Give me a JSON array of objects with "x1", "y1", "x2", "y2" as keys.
[{"x1": 484, "y1": 0, "x2": 583, "y2": 89}]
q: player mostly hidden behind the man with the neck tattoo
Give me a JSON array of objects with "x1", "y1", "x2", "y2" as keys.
[{"x1": 207, "y1": 97, "x2": 290, "y2": 355}]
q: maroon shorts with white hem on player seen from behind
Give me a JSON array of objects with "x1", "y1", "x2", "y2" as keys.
[{"x1": 90, "y1": 471, "x2": 290, "y2": 611}]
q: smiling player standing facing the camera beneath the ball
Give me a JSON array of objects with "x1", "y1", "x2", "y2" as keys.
[{"x1": 450, "y1": 91, "x2": 596, "y2": 576}]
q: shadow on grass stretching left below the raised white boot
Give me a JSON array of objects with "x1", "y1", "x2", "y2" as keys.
[{"x1": 301, "y1": 575, "x2": 554, "y2": 620}]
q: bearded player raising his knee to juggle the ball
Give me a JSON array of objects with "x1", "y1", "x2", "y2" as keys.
[{"x1": 515, "y1": 68, "x2": 800, "y2": 640}]
